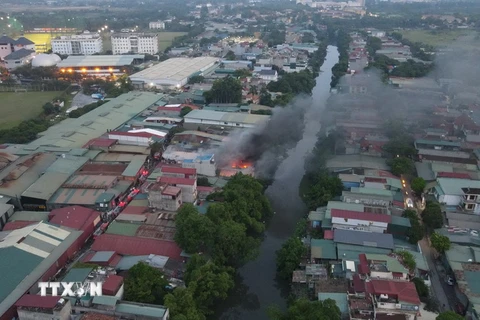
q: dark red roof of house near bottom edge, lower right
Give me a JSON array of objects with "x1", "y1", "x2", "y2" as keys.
[{"x1": 370, "y1": 280, "x2": 420, "y2": 305}]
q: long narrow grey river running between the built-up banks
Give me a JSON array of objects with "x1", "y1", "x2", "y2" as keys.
[{"x1": 216, "y1": 46, "x2": 338, "y2": 320}]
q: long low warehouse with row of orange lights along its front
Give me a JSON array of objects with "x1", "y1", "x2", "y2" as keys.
[{"x1": 57, "y1": 54, "x2": 145, "y2": 77}]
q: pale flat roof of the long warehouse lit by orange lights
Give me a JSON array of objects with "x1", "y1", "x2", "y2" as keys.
[{"x1": 57, "y1": 54, "x2": 145, "y2": 68}]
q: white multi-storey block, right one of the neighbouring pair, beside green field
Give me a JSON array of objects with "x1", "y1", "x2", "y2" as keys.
[{"x1": 112, "y1": 33, "x2": 158, "y2": 54}]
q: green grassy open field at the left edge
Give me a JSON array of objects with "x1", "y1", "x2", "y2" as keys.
[{"x1": 0, "y1": 91, "x2": 61, "y2": 129}]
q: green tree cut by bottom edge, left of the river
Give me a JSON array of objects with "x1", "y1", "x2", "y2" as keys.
[{"x1": 164, "y1": 288, "x2": 206, "y2": 320}]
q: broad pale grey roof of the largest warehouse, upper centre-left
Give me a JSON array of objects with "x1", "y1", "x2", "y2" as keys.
[{"x1": 130, "y1": 57, "x2": 218, "y2": 82}]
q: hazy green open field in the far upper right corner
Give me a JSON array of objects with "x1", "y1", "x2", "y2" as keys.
[{"x1": 401, "y1": 29, "x2": 475, "y2": 47}]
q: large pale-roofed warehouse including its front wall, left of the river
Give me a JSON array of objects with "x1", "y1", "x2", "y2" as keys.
[{"x1": 130, "y1": 57, "x2": 219, "y2": 89}]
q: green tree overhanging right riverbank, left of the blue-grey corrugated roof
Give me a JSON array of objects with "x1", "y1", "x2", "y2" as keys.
[{"x1": 277, "y1": 237, "x2": 307, "y2": 280}]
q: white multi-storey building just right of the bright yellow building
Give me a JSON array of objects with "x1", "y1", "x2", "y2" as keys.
[{"x1": 52, "y1": 31, "x2": 103, "y2": 55}]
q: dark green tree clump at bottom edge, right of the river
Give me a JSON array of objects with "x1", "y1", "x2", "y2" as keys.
[{"x1": 268, "y1": 299, "x2": 341, "y2": 320}]
